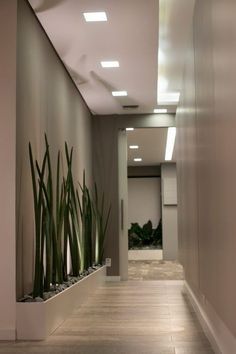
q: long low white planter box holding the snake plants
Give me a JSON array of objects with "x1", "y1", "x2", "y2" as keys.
[{"x1": 16, "y1": 266, "x2": 106, "y2": 340}]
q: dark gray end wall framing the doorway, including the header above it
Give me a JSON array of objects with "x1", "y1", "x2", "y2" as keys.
[{"x1": 93, "y1": 114, "x2": 175, "y2": 276}]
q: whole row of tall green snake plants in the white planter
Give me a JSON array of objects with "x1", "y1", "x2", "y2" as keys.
[{"x1": 29, "y1": 134, "x2": 110, "y2": 297}]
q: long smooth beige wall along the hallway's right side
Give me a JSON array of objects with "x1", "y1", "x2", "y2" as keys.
[{"x1": 177, "y1": 0, "x2": 236, "y2": 336}]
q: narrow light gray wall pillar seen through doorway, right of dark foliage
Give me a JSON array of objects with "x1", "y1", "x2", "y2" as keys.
[{"x1": 161, "y1": 163, "x2": 178, "y2": 261}]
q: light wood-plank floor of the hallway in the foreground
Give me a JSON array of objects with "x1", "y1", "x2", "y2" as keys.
[{"x1": 0, "y1": 281, "x2": 213, "y2": 354}]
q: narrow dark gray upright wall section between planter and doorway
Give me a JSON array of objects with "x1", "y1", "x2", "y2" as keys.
[{"x1": 93, "y1": 117, "x2": 119, "y2": 276}]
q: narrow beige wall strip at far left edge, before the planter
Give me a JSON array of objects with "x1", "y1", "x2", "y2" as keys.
[{"x1": 0, "y1": 0, "x2": 17, "y2": 339}]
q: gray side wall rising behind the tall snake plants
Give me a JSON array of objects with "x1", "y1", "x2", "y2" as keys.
[{"x1": 16, "y1": 1, "x2": 92, "y2": 296}]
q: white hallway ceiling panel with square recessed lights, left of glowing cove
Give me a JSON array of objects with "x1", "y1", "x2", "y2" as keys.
[{"x1": 29, "y1": 0, "x2": 158, "y2": 114}]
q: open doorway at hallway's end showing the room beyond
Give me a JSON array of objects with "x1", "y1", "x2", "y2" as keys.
[{"x1": 120, "y1": 128, "x2": 182, "y2": 280}]
